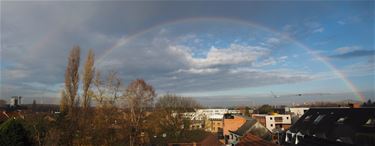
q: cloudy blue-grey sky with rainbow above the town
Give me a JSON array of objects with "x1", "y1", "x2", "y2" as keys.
[{"x1": 0, "y1": 1, "x2": 375, "y2": 106}]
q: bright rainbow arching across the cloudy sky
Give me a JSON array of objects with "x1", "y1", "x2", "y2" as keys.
[{"x1": 96, "y1": 17, "x2": 366, "y2": 102}]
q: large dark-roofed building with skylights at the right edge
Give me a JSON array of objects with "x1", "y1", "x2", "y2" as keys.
[{"x1": 280, "y1": 108, "x2": 375, "y2": 146}]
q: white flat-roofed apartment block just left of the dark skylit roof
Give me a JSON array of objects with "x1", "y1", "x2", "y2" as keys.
[{"x1": 252, "y1": 114, "x2": 292, "y2": 133}]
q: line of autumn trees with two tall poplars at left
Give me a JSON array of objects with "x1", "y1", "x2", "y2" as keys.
[{"x1": 0, "y1": 46, "x2": 206, "y2": 146}]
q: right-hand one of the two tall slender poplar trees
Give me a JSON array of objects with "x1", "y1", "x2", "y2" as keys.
[{"x1": 82, "y1": 49, "x2": 95, "y2": 110}]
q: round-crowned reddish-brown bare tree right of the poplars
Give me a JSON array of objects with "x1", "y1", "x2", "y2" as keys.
[{"x1": 124, "y1": 79, "x2": 156, "y2": 146}]
